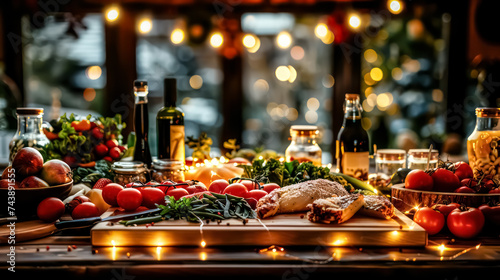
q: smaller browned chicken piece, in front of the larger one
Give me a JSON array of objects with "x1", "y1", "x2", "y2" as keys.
[{"x1": 307, "y1": 194, "x2": 364, "y2": 224}]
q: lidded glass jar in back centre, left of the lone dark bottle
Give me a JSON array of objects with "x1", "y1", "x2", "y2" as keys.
[{"x1": 285, "y1": 125, "x2": 321, "y2": 166}]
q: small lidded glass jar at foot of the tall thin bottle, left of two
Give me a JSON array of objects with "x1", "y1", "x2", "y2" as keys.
[{"x1": 111, "y1": 161, "x2": 149, "y2": 186}]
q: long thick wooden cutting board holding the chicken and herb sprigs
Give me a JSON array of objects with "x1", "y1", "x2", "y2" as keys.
[{"x1": 91, "y1": 210, "x2": 427, "y2": 247}]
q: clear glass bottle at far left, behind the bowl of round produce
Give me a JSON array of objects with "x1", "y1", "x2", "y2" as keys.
[{"x1": 9, "y1": 108, "x2": 50, "y2": 163}]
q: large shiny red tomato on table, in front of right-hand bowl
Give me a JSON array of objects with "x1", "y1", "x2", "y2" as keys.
[{"x1": 446, "y1": 207, "x2": 484, "y2": 239}]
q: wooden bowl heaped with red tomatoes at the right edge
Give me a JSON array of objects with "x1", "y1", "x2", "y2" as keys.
[{"x1": 391, "y1": 162, "x2": 500, "y2": 212}]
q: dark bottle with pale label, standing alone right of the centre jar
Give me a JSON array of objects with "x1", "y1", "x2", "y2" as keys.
[{"x1": 336, "y1": 93, "x2": 370, "y2": 180}]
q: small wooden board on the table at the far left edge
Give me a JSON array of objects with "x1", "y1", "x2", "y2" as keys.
[{"x1": 0, "y1": 220, "x2": 57, "y2": 244}]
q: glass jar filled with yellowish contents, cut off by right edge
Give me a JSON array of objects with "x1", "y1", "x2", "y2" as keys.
[{"x1": 467, "y1": 108, "x2": 500, "y2": 179}]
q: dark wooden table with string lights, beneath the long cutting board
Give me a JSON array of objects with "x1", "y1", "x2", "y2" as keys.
[{"x1": 0, "y1": 230, "x2": 500, "y2": 280}]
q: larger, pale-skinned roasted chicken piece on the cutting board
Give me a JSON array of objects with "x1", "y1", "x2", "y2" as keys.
[{"x1": 256, "y1": 179, "x2": 349, "y2": 218}]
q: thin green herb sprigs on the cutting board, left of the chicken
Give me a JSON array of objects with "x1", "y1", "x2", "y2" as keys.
[{"x1": 121, "y1": 193, "x2": 257, "y2": 226}]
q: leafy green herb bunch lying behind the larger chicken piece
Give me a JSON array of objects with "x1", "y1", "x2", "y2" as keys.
[{"x1": 240, "y1": 158, "x2": 354, "y2": 192}]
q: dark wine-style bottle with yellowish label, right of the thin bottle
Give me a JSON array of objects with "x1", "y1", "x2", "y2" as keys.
[{"x1": 156, "y1": 78, "x2": 186, "y2": 164}]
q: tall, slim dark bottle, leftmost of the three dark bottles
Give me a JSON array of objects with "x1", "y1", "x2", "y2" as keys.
[{"x1": 134, "y1": 81, "x2": 152, "y2": 168}]
